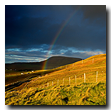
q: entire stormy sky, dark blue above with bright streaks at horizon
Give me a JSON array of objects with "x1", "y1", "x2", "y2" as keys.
[{"x1": 4, "y1": 5, "x2": 106, "y2": 63}]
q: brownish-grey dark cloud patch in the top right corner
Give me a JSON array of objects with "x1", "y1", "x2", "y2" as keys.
[{"x1": 72, "y1": 5, "x2": 106, "y2": 26}]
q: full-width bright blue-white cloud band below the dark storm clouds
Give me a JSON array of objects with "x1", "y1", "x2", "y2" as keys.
[{"x1": 5, "y1": 44, "x2": 105, "y2": 63}]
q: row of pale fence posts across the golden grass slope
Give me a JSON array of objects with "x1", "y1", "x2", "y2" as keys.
[{"x1": 35, "y1": 71, "x2": 98, "y2": 88}]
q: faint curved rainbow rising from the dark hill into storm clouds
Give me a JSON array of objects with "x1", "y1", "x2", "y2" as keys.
[{"x1": 42, "y1": 6, "x2": 82, "y2": 70}]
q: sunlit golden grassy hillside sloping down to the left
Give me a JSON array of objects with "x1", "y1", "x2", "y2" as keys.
[{"x1": 5, "y1": 54, "x2": 106, "y2": 105}]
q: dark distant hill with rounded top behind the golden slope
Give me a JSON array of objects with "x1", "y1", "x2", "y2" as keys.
[{"x1": 5, "y1": 56, "x2": 82, "y2": 71}]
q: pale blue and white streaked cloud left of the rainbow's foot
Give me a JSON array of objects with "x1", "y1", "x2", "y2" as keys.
[{"x1": 5, "y1": 49, "x2": 47, "y2": 63}]
